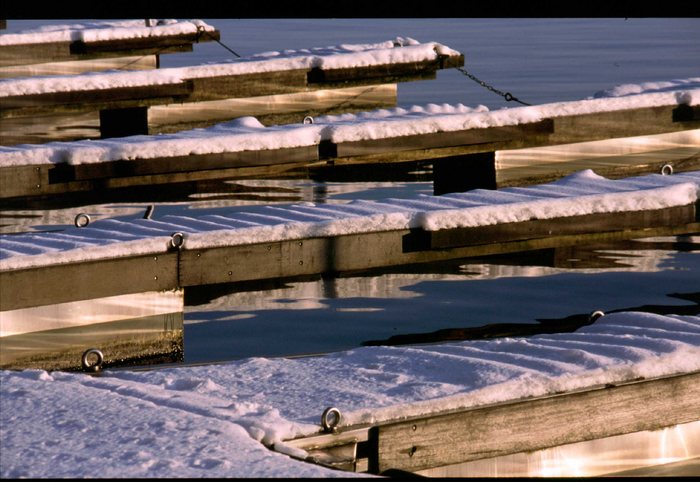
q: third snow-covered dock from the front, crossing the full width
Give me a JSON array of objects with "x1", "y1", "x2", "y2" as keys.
[{"x1": 0, "y1": 89, "x2": 700, "y2": 200}]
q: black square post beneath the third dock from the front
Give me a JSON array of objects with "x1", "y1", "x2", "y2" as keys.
[{"x1": 433, "y1": 152, "x2": 496, "y2": 196}]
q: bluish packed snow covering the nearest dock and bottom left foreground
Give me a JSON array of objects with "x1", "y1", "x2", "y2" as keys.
[{"x1": 0, "y1": 312, "x2": 700, "y2": 478}]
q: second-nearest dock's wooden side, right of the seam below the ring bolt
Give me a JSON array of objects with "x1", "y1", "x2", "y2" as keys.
[{"x1": 180, "y1": 214, "x2": 700, "y2": 286}]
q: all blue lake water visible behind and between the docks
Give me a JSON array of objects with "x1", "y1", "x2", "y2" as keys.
[{"x1": 0, "y1": 18, "x2": 700, "y2": 362}]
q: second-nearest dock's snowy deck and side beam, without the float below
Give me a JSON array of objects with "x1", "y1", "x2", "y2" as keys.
[{"x1": 0, "y1": 171, "x2": 700, "y2": 311}]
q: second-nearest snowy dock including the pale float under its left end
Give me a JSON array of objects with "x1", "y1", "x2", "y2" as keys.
[{"x1": 0, "y1": 165, "x2": 700, "y2": 369}]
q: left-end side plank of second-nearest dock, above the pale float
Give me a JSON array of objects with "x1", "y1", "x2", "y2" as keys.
[{"x1": 0, "y1": 252, "x2": 178, "y2": 311}]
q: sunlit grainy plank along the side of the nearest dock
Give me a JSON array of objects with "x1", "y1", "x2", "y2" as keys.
[{"x1": 370, "y1": 372, "x2": 700, "y2": 473}]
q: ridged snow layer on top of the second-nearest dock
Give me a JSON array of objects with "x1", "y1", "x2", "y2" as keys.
[{"x1": 0, "y1": 170, "x2": 700, "y2": 270}]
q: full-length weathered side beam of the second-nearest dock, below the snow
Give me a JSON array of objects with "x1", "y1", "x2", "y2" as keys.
[{"x1": 0, "y1": 222, "x2": 700, "y2": 310}]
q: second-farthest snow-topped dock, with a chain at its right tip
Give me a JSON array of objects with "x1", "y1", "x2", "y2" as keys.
[{"x1": 0, "y1": 26, "x2": 464, "y2": 145}]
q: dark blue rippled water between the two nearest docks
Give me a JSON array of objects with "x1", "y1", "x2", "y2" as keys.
[{"x1": 185, "y1": 236, "x2": 700, "y2": 361}]
